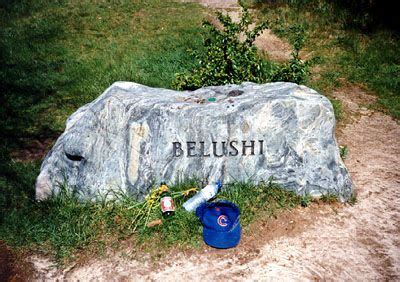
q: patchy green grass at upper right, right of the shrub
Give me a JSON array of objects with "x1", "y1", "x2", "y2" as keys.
[{"x1": 257, "y1": 1, "x2": 400, "y2": 118}]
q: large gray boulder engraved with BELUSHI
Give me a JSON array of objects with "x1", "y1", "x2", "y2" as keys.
[{"x1": 36, "y1": 82, "x2": 352, "y2": 200}]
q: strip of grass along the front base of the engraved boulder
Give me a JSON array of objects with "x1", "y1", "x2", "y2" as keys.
[{"x1": 0, "y1": 169, "x2": 302, "y2": 264}]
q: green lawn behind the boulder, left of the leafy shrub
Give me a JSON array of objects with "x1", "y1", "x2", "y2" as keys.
[{"x1": 0, "y1": 0, "x2": 202, "y2": 144}]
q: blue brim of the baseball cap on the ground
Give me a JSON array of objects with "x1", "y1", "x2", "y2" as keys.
[{"x1": 203, "y1": 224, "x2": 241, "y2": 249}]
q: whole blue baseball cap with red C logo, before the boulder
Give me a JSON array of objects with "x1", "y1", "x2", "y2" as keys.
[{"x1": 196, "y1": 201, "x2": 241, "y2": 249}]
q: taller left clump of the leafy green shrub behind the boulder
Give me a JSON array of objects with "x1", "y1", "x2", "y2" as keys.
[{"x1": 173, "y1": 3, "x2": 272, "y2": 90}]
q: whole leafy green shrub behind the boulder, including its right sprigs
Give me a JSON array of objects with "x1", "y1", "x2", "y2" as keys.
[{"x1": 173, "y1": 2, "x2": 316, "y2": 90}]
